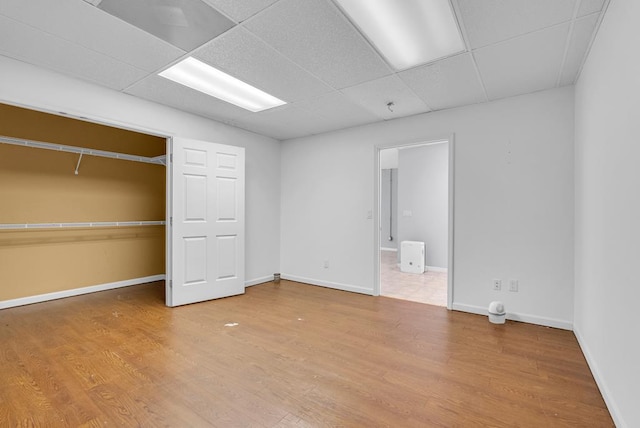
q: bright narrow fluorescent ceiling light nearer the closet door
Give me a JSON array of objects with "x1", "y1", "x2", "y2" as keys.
[{"x1": 160, "y1": 57, "x2": 286, "y2": 113}]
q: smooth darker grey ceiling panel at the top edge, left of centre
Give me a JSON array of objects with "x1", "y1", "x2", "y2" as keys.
[{"x1": 98, "y1": 0, "x2": 235, "y2": 51}]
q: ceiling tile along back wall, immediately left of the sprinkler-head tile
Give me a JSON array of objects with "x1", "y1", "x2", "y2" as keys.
[{"x1": 294, "y1": 92, "x2": 380, "y2": 129}]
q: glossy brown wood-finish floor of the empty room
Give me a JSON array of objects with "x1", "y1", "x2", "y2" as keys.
[{"x1": 0, "y1": 281, "x2": 613, "y2": 427}]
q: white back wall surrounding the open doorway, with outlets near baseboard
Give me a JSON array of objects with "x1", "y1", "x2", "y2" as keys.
[{"x1": 280, "y1": 87, "x2": 574, "y2": 328}]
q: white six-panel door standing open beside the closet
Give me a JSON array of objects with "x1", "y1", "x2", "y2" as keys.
[{"x1": 166, "y1": 138, "x2": 244, "y2": 306}]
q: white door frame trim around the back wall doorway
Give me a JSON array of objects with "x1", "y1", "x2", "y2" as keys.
[{"x1": 373, "y1": 134, "x2": 455, "y2": 310}]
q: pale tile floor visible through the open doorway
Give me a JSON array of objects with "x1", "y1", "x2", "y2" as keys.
[{"x1": 380, "y1": 251, "x2": 447, "y2": 306}]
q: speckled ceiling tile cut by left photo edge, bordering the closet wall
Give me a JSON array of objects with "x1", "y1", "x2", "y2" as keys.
[{"x1": 0, "y1": 15, "x2": 146, "y2": 90}]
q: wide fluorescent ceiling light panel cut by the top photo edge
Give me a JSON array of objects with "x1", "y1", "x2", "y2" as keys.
[{"x1": 335, "y1": 0, "x2": 465, "y2": 70}]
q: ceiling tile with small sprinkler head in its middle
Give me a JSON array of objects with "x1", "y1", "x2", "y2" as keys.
[{"x1": 342, "y1": 75, "x2": 429, "y2": 119}]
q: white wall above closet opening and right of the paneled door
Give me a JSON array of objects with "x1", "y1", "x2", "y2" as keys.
[{"x1": 0, "y1": 56, "x2": 280, "y2": 283}]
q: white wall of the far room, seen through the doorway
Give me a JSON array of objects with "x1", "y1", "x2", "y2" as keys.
[{"x1": 398, "y1": 143, "x2": 449, "y2": 269}]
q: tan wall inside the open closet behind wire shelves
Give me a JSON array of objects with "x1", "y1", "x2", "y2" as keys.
[{"x1": 0, "y1": 104, "x2": 166, "y2": 300}]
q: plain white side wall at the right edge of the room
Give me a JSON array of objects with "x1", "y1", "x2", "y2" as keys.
[{"x1": 574, "y1": 0, "x2": 640, "y2": 427}]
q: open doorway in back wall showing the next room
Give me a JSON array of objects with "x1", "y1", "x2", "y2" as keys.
[{"x1": 376, "y1": 138, "x2": 453, "y2": 308}]
